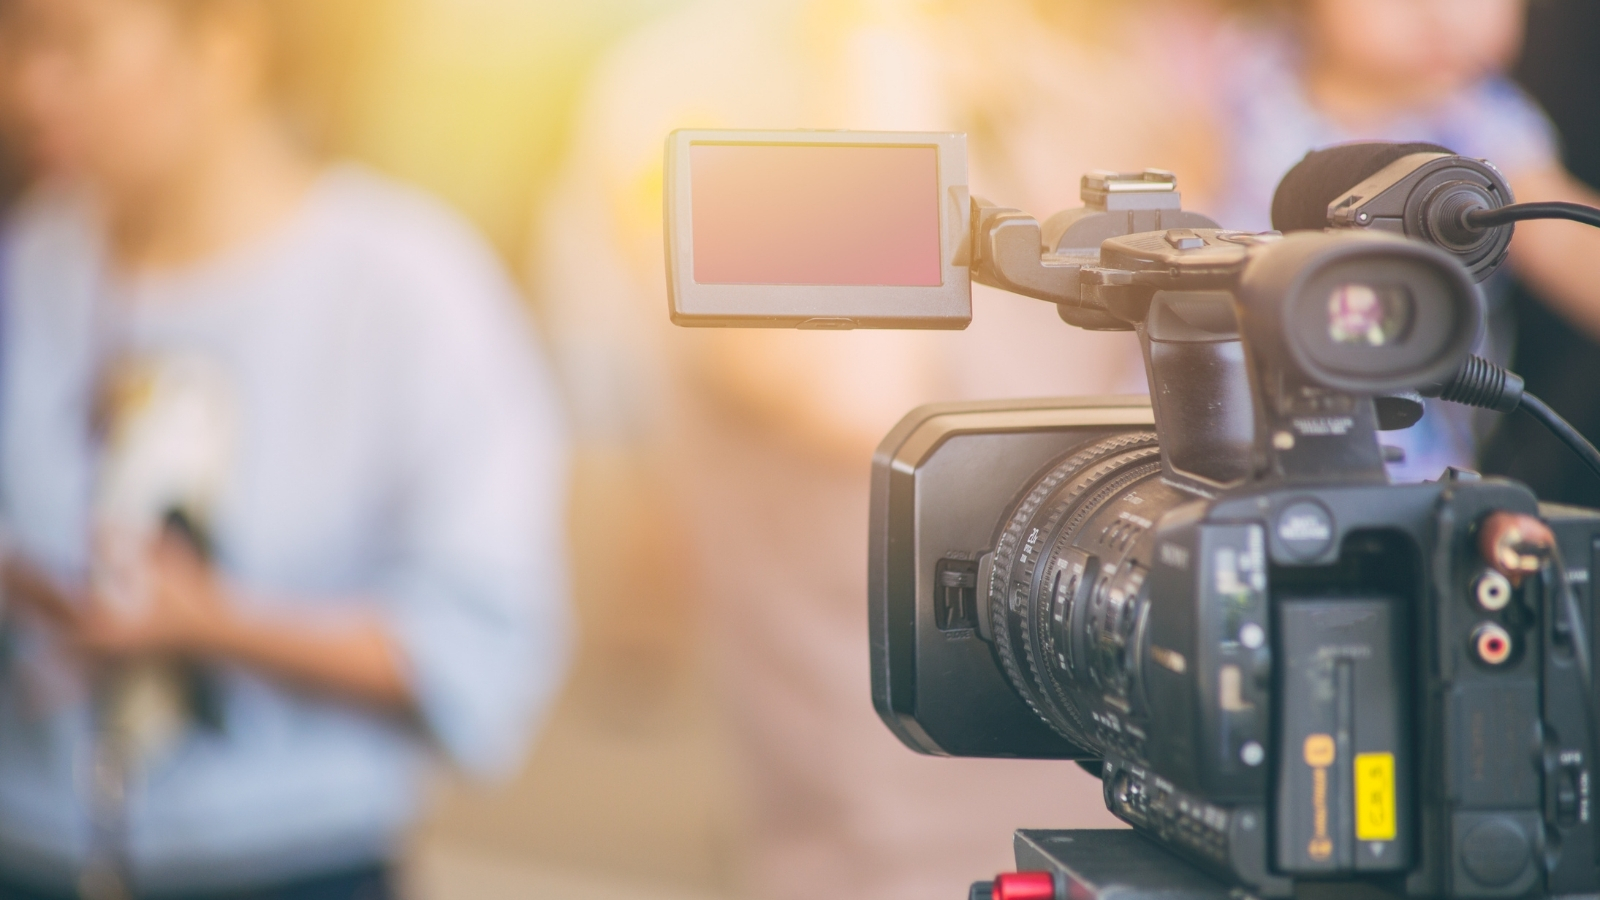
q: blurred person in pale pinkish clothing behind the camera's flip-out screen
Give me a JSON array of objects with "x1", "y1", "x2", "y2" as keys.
[{"x1": 534, "y1": 0, "x2": 1209, "y2": 900}]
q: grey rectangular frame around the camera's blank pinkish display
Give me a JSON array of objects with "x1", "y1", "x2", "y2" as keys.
[{"x1": 666, "y1": 130, "x2": 973, "y2": 330}]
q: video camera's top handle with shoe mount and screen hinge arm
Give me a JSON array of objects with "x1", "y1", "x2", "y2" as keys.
[{"x1": 971, "y1": 201, "x2": 1386, "y2": 493}]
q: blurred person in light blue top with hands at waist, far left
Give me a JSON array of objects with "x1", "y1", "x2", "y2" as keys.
[{"x1": 0, "y1": 0, "x2": 566, "y2": 900}]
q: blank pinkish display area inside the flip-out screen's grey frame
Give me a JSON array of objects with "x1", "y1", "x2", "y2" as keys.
[{"x1": 690, "y1": 144, "x2": 941, "y2": 287}]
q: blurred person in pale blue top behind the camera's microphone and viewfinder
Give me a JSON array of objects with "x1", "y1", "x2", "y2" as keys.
[{"x1": 1171, "y1": 0, "x2": 1600, "y2": 480}]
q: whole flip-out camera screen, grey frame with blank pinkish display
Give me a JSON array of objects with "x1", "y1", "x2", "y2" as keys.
[{"x1": 666, "y1": 131, "x2": 973, "y2": 330}]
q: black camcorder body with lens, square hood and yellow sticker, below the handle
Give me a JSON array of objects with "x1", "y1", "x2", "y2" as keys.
[{"x1": 870, "y1": 389, "x2": 1600, "y2": 897}]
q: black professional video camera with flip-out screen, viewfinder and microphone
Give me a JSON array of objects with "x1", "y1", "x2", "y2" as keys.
[{"x1": 667, "y1": 131, "x2": 1600, "y2": 898}]
